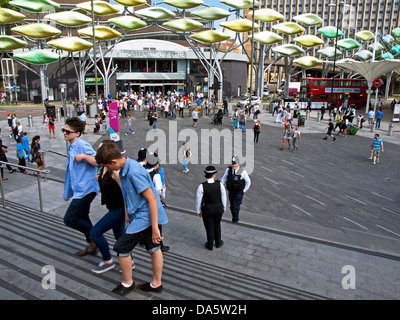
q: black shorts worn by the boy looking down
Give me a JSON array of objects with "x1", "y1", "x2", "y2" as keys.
[{"x1": 114, "y1": 225, "x2": 161, "y2": 257}]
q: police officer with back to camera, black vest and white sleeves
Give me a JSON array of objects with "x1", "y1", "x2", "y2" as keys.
[{"x1": 196, "y1": 166, "x2": 226, "y2": 250}]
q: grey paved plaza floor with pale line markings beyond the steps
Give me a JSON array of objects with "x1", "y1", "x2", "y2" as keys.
[{"x1": 0, "y1": 102, "x2": 400, "y2": 300}]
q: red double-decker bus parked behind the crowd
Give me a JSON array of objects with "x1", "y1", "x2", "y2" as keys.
[{"x1": 300, "y1": 78, "x2": 368, "y2": 108}]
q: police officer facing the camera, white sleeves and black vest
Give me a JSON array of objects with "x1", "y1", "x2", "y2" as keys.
[{"x1": 221, "y1": 156, "x2": 251, "y2": 224}]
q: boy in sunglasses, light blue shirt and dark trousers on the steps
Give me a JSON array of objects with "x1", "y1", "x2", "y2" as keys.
[{"x1": 62, "y1": 117, "x2": 99, "y2": 256}]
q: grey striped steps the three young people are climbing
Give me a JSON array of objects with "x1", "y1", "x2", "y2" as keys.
[{"x1": 0, "y1": 202, "x2": 324, "y2": 300}]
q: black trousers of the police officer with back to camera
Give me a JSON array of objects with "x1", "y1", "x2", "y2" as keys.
[{"x1": 201, "y1": 203, "x2": 224, "y2": 248}]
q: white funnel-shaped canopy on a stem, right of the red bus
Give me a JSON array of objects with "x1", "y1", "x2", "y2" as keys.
[{"x1": 336, "y1": 59, "x2": 400, "y2": 113}]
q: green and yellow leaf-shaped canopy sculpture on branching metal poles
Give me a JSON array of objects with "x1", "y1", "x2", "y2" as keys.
[{"x1": 4, "y1": 0, "x2": 400, "y2": 102}]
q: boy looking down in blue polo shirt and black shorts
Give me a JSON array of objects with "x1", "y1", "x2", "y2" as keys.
[{"x1": 96, "y1": 141, "x2": 168, "y2": 295}]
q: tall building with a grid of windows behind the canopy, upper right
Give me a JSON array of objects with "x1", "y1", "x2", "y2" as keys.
[{"x1": 246, "y1": 0, "x2": 400, "y2": 87}]
